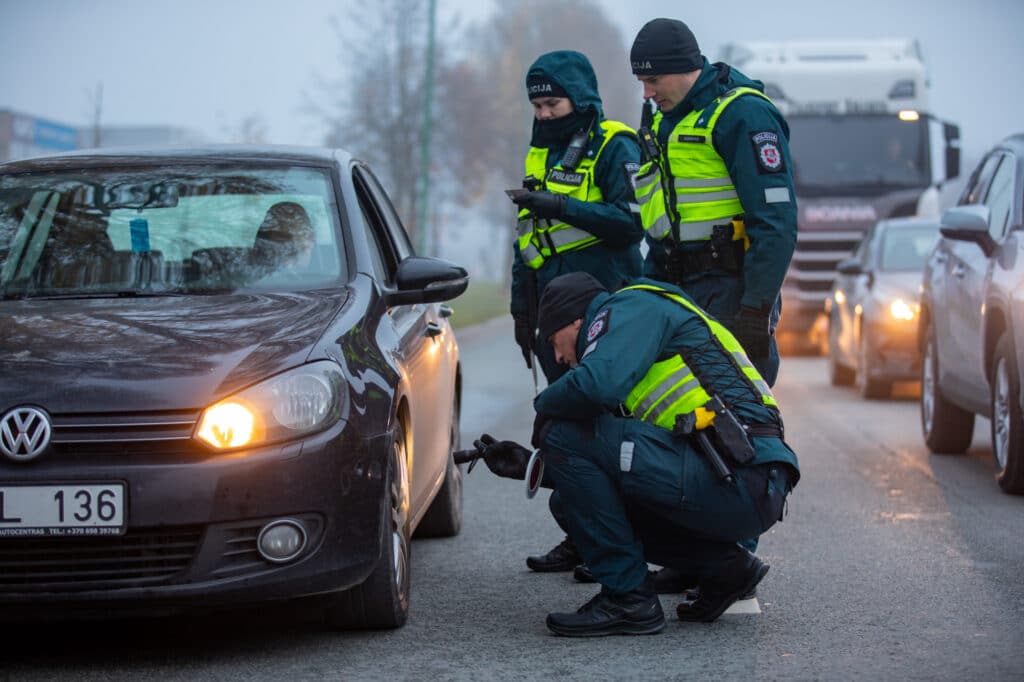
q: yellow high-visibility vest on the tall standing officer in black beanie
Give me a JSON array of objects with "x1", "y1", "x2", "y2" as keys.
[{"x1": 635, "y1": 87, "x2": 770, "y2": 247}]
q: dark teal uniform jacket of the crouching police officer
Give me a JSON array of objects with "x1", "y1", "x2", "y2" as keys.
[{"x1": 534, "y1": 279, "x2": 798, "y2": 468}]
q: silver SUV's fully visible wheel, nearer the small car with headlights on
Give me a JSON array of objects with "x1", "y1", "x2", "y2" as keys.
[{"x1": 921, "y1": 326, "x2": 974, "y2": 455}]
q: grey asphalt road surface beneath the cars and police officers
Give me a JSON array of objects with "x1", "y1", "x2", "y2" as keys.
[{"x1": 6, "y1": 319, "x2": 1024, "y2": 681}]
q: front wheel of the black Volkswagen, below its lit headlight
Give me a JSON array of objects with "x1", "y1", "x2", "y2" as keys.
[{"x1": 326, "y1": 421, "x2": 412, "y2": 630}]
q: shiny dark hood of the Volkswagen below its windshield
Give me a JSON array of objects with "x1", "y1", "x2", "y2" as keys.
[{"x1": 0, "y1": 289, "x2": 349, "y2": 413}]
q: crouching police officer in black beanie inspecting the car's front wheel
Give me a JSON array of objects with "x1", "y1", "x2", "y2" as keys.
[{"x1": 464, "y1": 272, "x2": 800, "y2": 636}]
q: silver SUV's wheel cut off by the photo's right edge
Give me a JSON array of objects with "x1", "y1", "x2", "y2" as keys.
[{"x1": 989, "y1": 334, "x2": 1024, "y2": 495}]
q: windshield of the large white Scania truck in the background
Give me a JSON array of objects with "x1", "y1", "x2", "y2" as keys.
[{"x1": 787, "y1": 114, "x2": 931, "y2": 196}]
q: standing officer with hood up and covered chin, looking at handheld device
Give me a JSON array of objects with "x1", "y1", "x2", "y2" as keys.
[{"x1": 510, "y1": 50, "x2": 643, "y2": 571}]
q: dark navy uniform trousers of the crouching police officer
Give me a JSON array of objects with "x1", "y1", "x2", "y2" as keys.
[{"x1": 542, "y1": 415, "x2": 792, "y2": 592}]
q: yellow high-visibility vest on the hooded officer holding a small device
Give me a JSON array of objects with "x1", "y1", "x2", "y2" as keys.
[{"x1": 516, "y1": 121, "x2": 636, "y2": 269}]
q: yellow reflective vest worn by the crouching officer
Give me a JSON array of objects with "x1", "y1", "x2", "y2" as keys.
[{"x1": 620, "y1": 285, "x2": 778, "y2": 430}]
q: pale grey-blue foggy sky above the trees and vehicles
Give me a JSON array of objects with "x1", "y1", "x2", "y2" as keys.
[{"x1": 0, "y1": 0, "x2": 1024, "y2": 151}]
